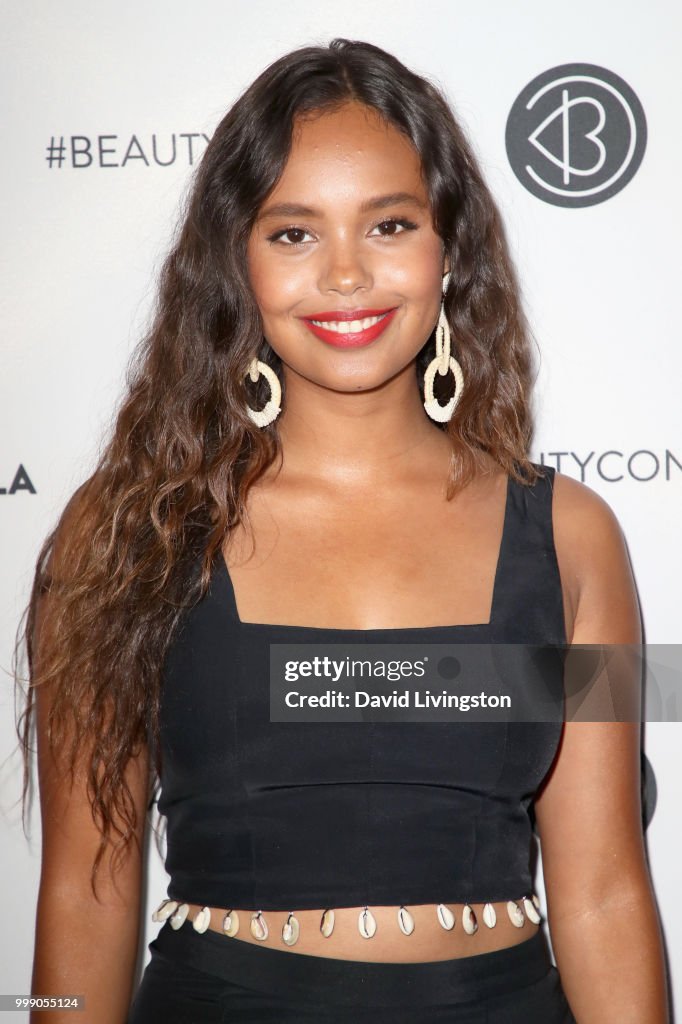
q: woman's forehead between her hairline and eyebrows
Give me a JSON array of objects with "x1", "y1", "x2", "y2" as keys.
[{"x1": 270, "y1": 102, "x2": 426, "y2": 202}]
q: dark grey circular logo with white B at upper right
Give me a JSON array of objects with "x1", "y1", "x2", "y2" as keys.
[{"x1": 505, "y1": 63, "x2": 646, "y2": 207}]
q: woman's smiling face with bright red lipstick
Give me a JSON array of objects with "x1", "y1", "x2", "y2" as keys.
[{"x1": 247, "y1": 103, "x2": 449, "y2": 391}]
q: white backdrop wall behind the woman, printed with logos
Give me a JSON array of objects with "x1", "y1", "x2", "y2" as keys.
[{"x1": 0, "y1": 0, "x2": 682, "y2": 1021}]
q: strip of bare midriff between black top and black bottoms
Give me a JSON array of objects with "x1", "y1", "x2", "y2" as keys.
[{"x1": 173, "y1": 901, "x2": 541, "y2": 964}]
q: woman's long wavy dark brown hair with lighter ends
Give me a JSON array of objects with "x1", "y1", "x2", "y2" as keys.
[{"x1": 15, "y1": 39, "x2": 540, "y2": 892}]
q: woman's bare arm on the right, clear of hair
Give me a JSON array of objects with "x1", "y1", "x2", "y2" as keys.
[{"x1": 535, "y1": 474, "x2": 669, "y2": 1024}]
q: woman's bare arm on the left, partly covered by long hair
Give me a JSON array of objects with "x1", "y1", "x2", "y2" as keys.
[{"x1": 31, "y1": 491, "x2": 148, "y2": 1024}]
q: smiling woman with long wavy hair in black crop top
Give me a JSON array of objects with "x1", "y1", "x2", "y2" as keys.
[{"x1": 19, "y1": 40, "x2": 666, "y2": 1024}]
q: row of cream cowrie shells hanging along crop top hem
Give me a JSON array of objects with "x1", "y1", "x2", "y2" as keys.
[{"x1": 152, "y1": 893, "x2": 542, "y2": 946}]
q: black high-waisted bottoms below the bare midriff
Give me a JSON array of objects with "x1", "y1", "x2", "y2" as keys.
[{"x1": 127, "y1": 924, "x2": 576, "y2": 1024}]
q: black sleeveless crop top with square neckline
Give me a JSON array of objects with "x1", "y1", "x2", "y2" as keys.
[{"x1": 159, "y1": 467, "x2": 566, "y2": 910}]
